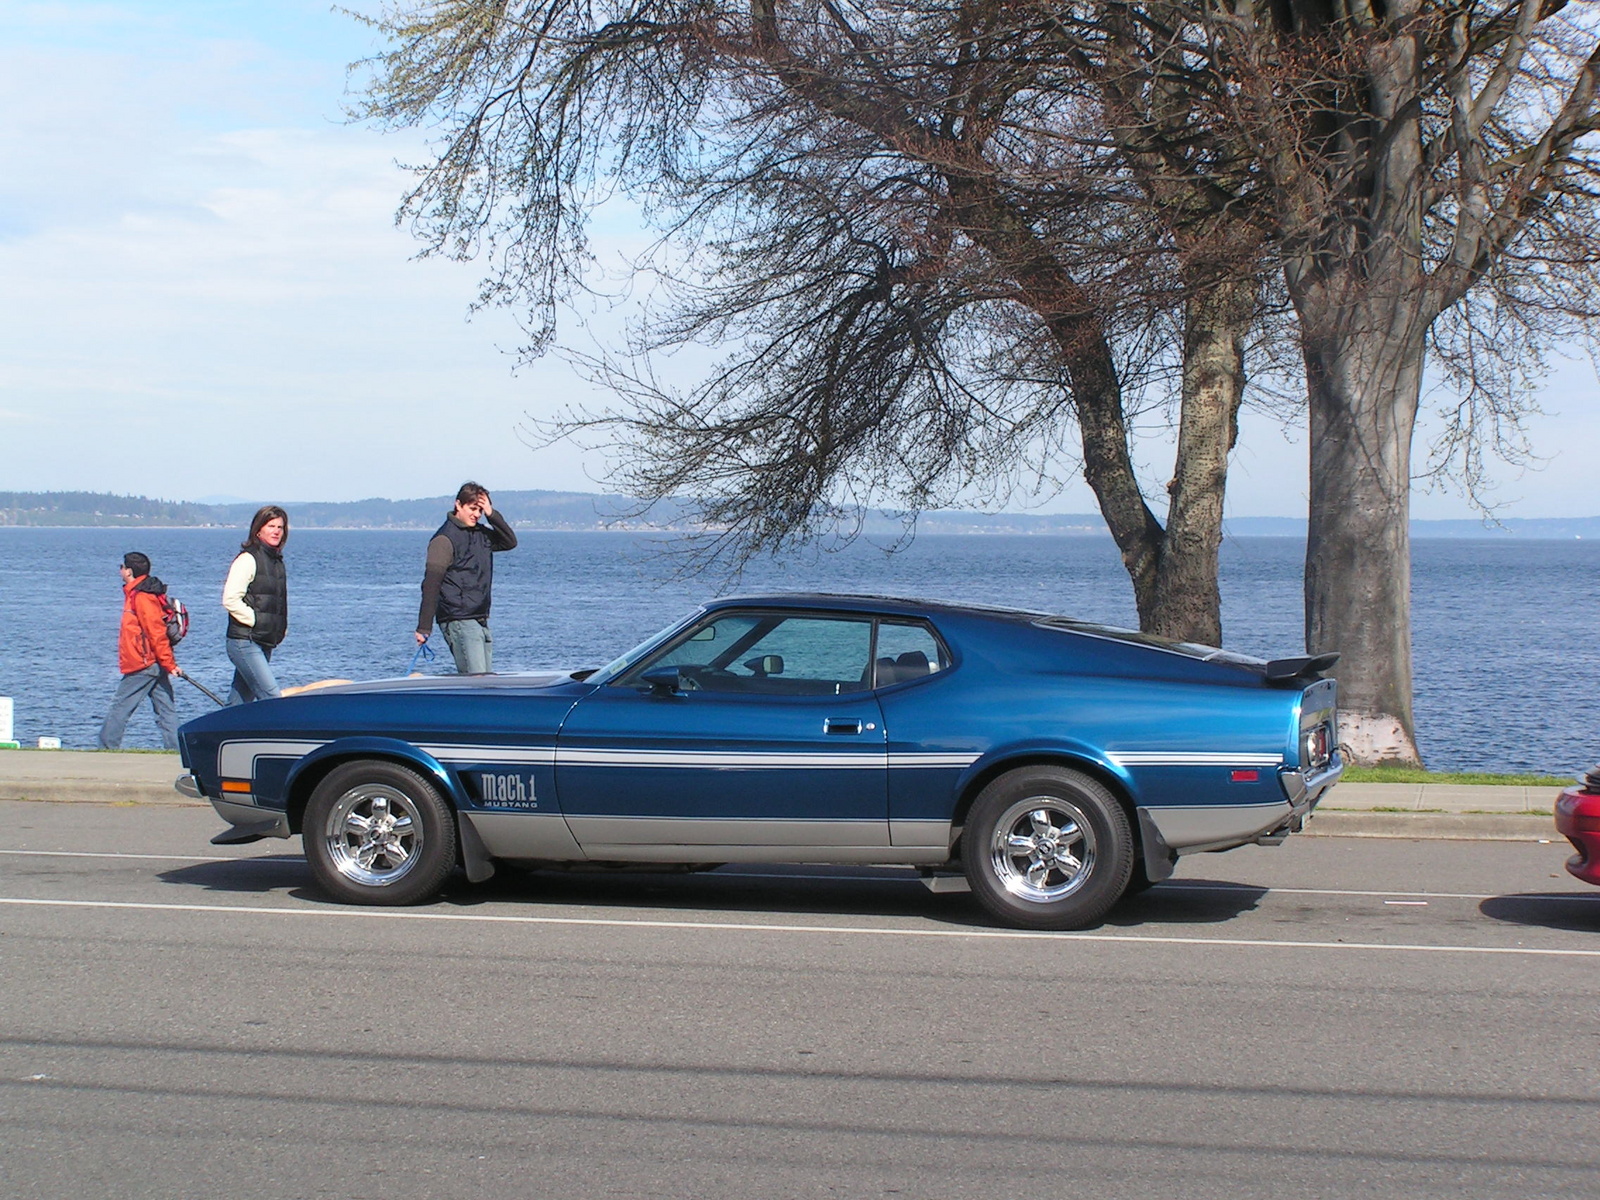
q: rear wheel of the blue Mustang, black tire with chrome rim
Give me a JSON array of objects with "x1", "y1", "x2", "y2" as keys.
[{"x1": 962, "y1": 766, "x2": 1134, "y2": 930}]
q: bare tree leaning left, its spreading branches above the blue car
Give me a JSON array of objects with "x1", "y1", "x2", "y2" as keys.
[{"x1": 356, "y1": 0, "x2": 1280, "y2": 642}]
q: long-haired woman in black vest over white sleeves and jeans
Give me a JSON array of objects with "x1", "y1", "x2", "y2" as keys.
[{"x1": 222, "y1": 504, "x2": 290, "y2": 704}]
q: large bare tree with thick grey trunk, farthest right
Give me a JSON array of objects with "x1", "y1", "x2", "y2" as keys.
[{"x1": 1206, "y1": 0, "x2": 1600, "y2": 762}]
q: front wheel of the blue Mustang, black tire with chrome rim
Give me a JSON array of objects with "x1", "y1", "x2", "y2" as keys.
[{"x1": 301, "y1": 760, "x2": 456, "y2": 904}]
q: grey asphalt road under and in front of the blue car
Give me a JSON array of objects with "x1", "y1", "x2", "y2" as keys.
[{"x1": 0, "y1": 803, "x2": 1600, "y2": 1200}]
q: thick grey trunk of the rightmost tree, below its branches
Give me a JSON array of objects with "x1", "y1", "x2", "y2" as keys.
[{"x1": 1301, "y1": 315, "x2": 1422, "y2": 766}]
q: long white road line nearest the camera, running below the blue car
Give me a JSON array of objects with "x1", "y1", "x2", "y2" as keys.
[{"x1": 0, "y1": 896, "x2": 1600, "y2": 958}]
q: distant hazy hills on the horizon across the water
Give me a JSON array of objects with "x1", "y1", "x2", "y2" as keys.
[{"x1": 0, "y1": 491, "x2": 1600, "y2": 539}]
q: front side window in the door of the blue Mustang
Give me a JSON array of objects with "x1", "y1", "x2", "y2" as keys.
[{"x1": 618, "y1": 613, "x2": 872, "y2": 696}]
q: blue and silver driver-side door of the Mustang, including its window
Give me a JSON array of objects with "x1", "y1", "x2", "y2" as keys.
[{"x1": 555, "y1": 610, "x2": 890, "y2": 861}]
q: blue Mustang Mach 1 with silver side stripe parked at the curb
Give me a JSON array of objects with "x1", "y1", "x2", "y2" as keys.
[{"x1": 178, "y1": 595, "x2": 1344, "y2": 930}]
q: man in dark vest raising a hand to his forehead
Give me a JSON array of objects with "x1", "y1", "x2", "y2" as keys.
[{"x1": 416, "y1": 483, "x2": 517, "y2": 675}]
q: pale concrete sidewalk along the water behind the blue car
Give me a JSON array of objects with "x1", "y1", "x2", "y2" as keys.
[{"x1": 0, "y1": 750, "x2": 1560, "y2": 842}]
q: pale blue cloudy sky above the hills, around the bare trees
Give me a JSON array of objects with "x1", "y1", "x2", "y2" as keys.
[{"x1": 0, "y1": 0, "x2": 1600, "y2": 517}]
